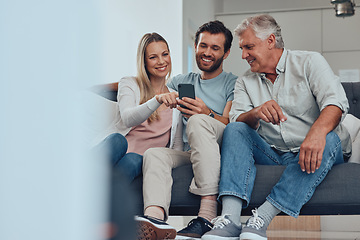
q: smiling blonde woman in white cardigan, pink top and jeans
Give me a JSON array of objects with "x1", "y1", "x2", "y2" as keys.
[{"x1": 98, "y1": 33, "x2": 183, "y2": 181}]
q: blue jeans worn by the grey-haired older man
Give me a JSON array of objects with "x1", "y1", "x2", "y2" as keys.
[{"x1": 219, "y1": 122, "x2": 344, "y2": 217}]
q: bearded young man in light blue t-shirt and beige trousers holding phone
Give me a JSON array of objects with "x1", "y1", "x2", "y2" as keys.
[{"x1": 136, "y1": 21, "x2": 237, "y2": 239}]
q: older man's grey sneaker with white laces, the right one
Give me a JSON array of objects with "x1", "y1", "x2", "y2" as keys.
[{"x1": 240, "y1": 209, "x2": 267, "y2": 240}]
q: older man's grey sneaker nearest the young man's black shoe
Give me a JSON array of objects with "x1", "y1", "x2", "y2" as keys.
[{"x1": 201, "y1": 215, "x2": 241, "y2": 240}]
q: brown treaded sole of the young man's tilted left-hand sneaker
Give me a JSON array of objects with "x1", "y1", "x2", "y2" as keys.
[{"x1": 137, "y1": 219, "x2": 176, "y2": 240}]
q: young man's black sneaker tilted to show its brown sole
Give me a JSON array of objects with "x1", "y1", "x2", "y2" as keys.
[{"x1": 135, "y1": 216, "x2": 176, "y2": 240}]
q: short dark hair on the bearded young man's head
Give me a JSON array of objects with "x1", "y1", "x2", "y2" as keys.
[{"x1": 195, "y1": 20, "x2": 233, "y2": 52}]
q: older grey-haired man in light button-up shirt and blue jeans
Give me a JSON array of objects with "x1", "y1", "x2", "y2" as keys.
[{"x1": 201, "y1": 14, "x2": 351, "y2": 240}]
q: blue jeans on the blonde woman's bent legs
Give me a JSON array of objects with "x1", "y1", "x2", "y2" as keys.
[{"x1": 96, "y1": 133, "x2": 143, "y2": 182}]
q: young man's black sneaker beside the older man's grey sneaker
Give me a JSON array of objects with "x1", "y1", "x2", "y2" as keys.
[{"x1": 176, "y1": 217, "x2": 213, "y2": 239}]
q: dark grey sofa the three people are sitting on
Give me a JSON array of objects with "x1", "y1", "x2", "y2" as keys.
[{"x1": 98, "y1": 82, "x2": 360, "y2": 216}]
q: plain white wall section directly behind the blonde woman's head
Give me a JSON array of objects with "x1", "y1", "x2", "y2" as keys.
[{"x1": 98, "y1": 0, "x2": 183, "y2": 83}]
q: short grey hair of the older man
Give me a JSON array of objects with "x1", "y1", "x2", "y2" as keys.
[{"x1": 235, "y1": 14, "x2": 284, "y2": 48}]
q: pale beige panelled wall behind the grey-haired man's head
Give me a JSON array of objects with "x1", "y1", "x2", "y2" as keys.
[{"x1": 216, "y1": 4, "x2": 360, "y2": 81}]
